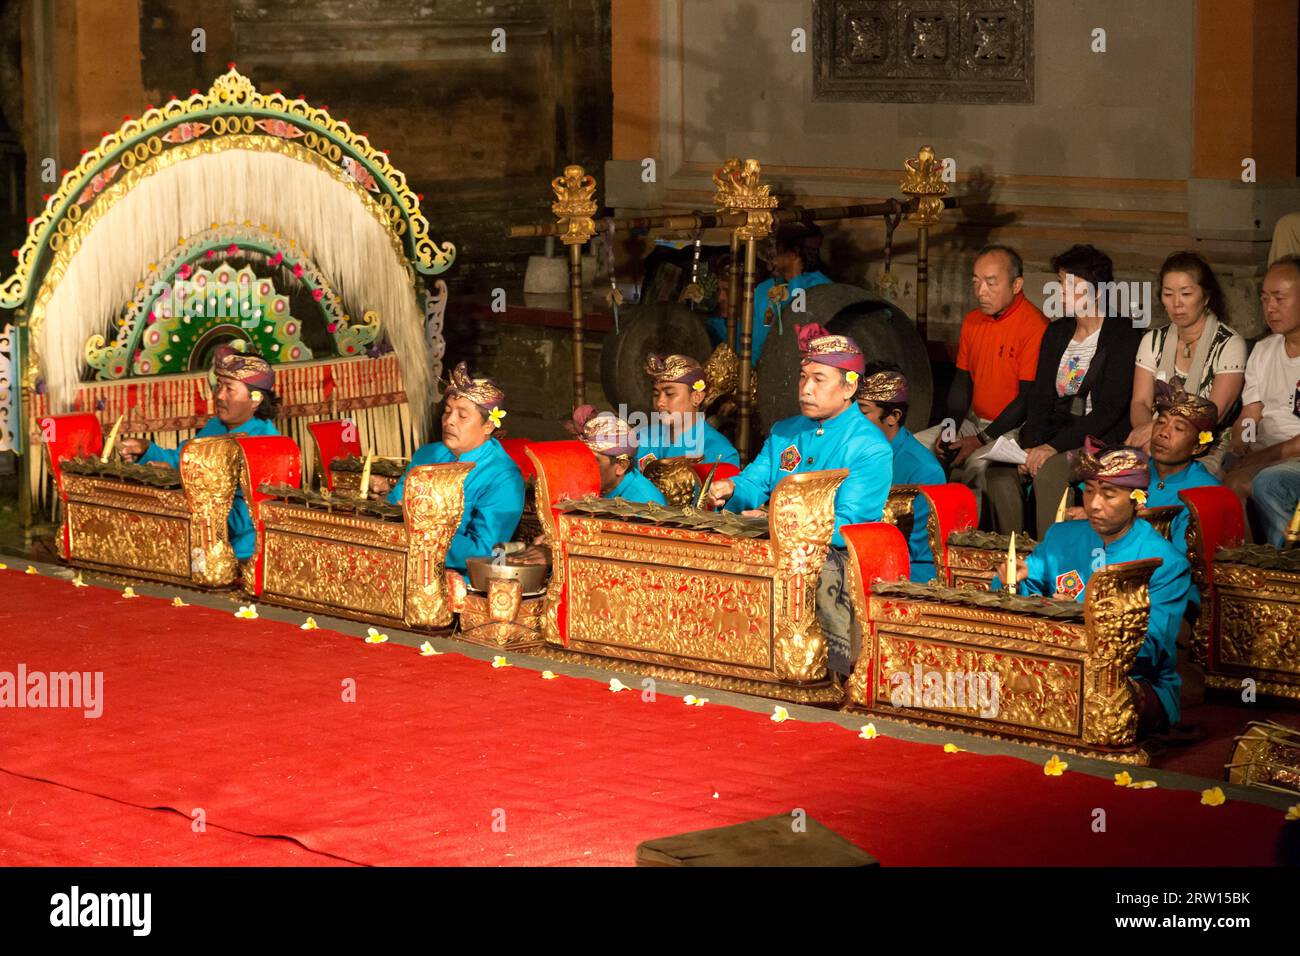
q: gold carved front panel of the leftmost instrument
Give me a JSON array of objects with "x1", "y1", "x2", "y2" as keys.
[{"x1": 66, "y1": 504, "x2": 191, "y2": 581}]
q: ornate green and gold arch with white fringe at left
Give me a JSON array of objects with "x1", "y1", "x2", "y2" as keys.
[{"x1": 0, "y1": 64, "x2": 455, "y2": 509}]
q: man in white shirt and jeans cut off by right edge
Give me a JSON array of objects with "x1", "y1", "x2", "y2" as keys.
[{"x1": 1223, "y1": 256, "x2": 1300, "y2": 548}]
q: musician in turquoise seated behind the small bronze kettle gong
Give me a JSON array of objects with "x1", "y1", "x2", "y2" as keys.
[{"x1": 371, "y1": 362, "x2": 524, "y2": 575}]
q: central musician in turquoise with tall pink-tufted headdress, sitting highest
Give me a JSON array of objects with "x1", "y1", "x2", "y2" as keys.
[{"x1": 709, "y1": 324, "x2": 893, "y2": 675}]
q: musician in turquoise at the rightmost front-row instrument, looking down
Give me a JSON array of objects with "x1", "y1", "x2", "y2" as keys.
[{"x1": 992, "y1": 438, "x2": 1191, "y2": 737}]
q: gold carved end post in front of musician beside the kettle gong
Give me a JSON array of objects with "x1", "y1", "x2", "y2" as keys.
[{"x1": 403, "y1": 462, "x2": 475, "y2": 627}]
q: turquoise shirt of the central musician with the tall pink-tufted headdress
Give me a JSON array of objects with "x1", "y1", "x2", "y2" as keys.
[{"x1": 724, "y1": 405, "x2": 893, "y2": 548}]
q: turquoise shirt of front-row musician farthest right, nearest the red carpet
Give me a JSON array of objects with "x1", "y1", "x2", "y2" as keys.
[{"x1": 993, "y1": 519, "x2": 1192, "y2": 724}]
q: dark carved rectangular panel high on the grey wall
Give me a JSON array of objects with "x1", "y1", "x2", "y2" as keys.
[{"x1": 813, "y1": 0, "x2": 1034, "y2": 103}]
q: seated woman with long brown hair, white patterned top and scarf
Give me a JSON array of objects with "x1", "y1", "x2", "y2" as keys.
[{"x1": 1125, "y1": 252, "x2": 1249, "y2": 475}]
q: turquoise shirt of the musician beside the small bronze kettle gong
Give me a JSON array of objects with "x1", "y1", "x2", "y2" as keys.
[{"x1": 389, "y1": 438, "x2": 524, "y2": 574}]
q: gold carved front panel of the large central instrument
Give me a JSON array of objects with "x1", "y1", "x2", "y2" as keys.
[{"x1": 568, "y1": 554, "x2": 772, "y2": 670}]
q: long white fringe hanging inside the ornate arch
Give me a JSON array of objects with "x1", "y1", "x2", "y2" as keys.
[{"x1": 38, "y1": 150, "x2": 436, "y2": 434}]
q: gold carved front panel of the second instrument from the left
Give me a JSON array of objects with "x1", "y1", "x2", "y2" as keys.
[{"x1": 263, "y1": 527, "x2": 406, "y2": 620}]
